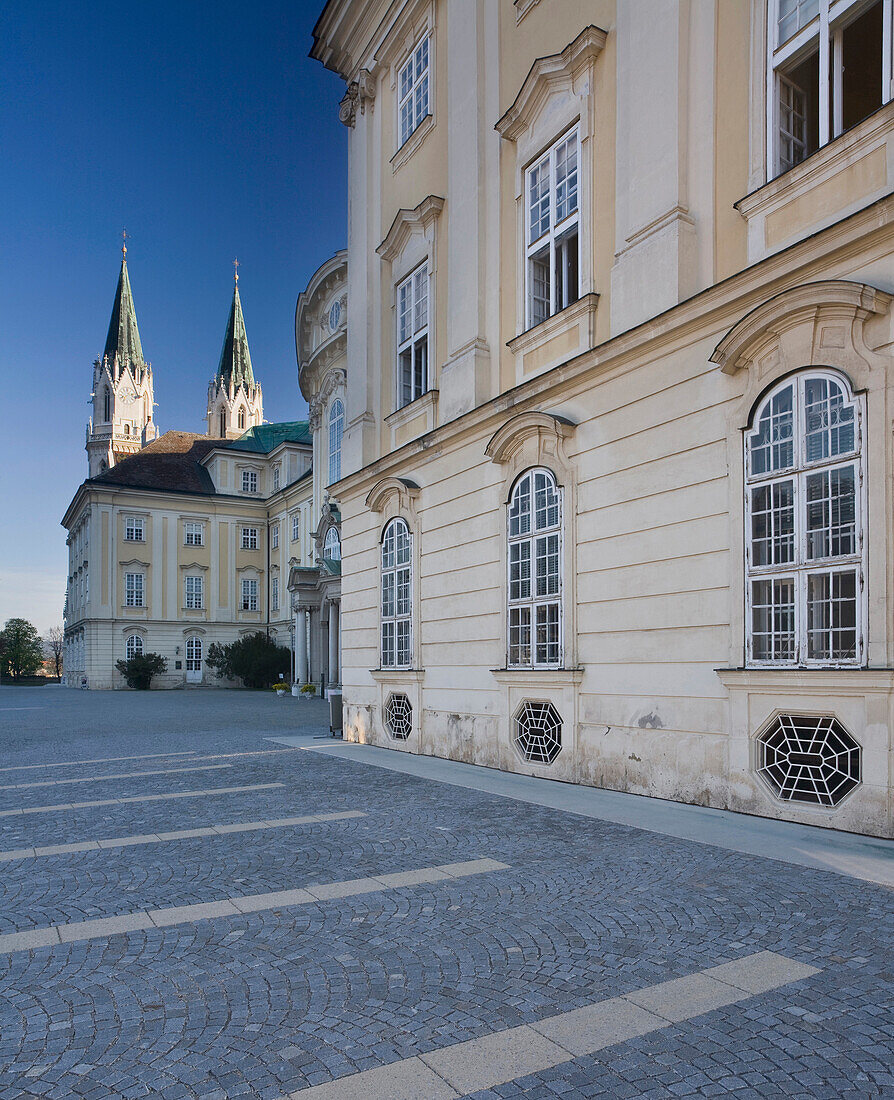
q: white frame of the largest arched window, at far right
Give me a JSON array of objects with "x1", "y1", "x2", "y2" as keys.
[{"x1": 743, "y1": 367, "x2": 869, "y2": 668}]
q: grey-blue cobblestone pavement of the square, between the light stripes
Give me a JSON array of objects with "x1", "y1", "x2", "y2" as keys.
[{"x1": 0, "y1": 688, "x2": 894, "y2": 1100}]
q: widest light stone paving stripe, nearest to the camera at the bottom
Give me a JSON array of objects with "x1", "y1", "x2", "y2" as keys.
[{"x1": 283, "y1": 952, "x2": 820, "y2": 1100}]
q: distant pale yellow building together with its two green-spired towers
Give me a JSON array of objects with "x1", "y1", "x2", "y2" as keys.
[{"x1": 63, "y1": 256, "x2": 314, "y2": 689}]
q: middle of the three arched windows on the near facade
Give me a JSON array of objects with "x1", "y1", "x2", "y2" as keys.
[{"x1": 508, "y1": 469, "x2": 562, "y2": 669}]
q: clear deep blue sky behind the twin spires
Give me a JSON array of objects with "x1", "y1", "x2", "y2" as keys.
[{"x1": 0, "y1": 0, "x2": 347, "y2": 633}]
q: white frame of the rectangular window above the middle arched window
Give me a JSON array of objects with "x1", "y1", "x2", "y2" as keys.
[{"x1": 523, "y1": 123, "x2": 581, "y2": 329}]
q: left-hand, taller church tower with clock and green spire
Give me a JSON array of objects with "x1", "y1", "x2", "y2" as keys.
[{"x1": 86, "y1": 239, "x2": 157, "y2": 477}]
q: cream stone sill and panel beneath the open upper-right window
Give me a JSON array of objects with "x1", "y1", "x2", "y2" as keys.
[{"x1": 733, "y1": 100, "x2": 894, "y2": 264}]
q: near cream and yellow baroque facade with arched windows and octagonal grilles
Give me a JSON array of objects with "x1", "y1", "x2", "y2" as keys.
[{"x1": 310, "y1": 0, "x2": 894, "y2": 836}]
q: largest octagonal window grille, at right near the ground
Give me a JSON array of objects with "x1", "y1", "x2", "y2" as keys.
[{"x1": 758, "y1": 714, "x2": 862, "y2": 806}]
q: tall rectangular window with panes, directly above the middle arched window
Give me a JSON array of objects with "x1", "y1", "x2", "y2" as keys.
[{"x1": 525, "y1": 130, "x2": 581, "y2": 329}]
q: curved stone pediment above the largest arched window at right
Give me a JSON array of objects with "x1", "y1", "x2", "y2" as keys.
[{"x1": 710, "y1": 279, "x2": 892, "y2": 374}]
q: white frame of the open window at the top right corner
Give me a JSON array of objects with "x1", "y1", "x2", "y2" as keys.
[{"x1": 766, "y1": 0, "x2": 894, "y2": 180}]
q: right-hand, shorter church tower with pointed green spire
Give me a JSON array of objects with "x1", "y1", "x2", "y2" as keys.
[{"x1": 208, "y1": 261, "x2": 264, "y2": 439}]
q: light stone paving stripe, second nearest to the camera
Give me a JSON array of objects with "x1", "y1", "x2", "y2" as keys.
[{"x1": 0, "y1": 859, "x2": 509, "y2": 955}]
